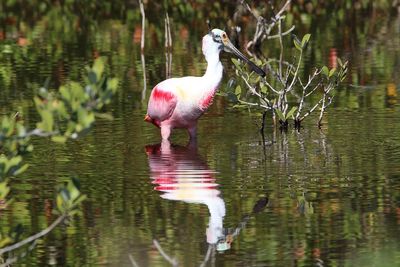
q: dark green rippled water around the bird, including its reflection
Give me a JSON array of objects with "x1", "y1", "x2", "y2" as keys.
[{"x1": 0, "y1": 1, "x2": 400, "y2": 266}]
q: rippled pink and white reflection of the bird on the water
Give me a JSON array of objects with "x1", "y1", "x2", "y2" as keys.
[{"x1": 146, "y1": 141, "x2": 225, "y2": 244}]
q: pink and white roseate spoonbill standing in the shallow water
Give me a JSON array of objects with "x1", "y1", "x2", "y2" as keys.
[{"x1": 144, "y1": 29, "x2": 265, "y2": 140}]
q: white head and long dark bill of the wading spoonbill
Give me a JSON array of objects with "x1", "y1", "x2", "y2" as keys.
[{"x1": 203, "y1": 29, "x2": 266, "y2": 77}]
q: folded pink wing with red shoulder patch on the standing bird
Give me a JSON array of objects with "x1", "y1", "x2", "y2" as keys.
[{"x1": 147, "y1": 86, "x2": 177, "y2": 123}]
